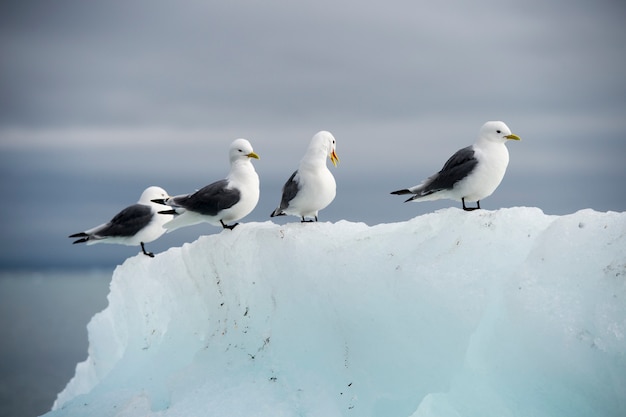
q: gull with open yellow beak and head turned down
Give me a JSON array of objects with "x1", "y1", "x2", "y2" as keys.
[{"x1": 270, "y1": 131, "x2": 339, "y2": 222}]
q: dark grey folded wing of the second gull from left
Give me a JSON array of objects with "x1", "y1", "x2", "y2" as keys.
[{"x1": 174, "y1": 180, "x2": 241, "y2": 216}]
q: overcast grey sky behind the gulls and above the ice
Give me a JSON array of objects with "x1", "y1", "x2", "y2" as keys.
[{"x1": 0, "y1": 0, "x2": 626, "y2": 267}]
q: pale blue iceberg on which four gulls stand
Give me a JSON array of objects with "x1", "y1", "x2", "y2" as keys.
[{"x1": 46, "y1": 207, "x2": 626, "y2": 417}]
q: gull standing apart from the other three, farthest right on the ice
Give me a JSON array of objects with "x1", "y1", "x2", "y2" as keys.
[{"x1": 391, "y1": 121, "x2": 520, "y2": 211}]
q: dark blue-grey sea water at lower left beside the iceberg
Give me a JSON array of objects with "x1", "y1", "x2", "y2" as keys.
[{"x1": 0, "y1": 268, "x2": 113, "y2": 417}]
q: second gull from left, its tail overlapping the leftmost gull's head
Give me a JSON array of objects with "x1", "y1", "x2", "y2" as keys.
[{"x1": 152, "y1": 139, "x2": 260, "y2": 232}]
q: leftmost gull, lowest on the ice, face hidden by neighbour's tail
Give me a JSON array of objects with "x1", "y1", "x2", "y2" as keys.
[{"x1": 69, "y1": 186, "x2": 173, "y2": 258}]
